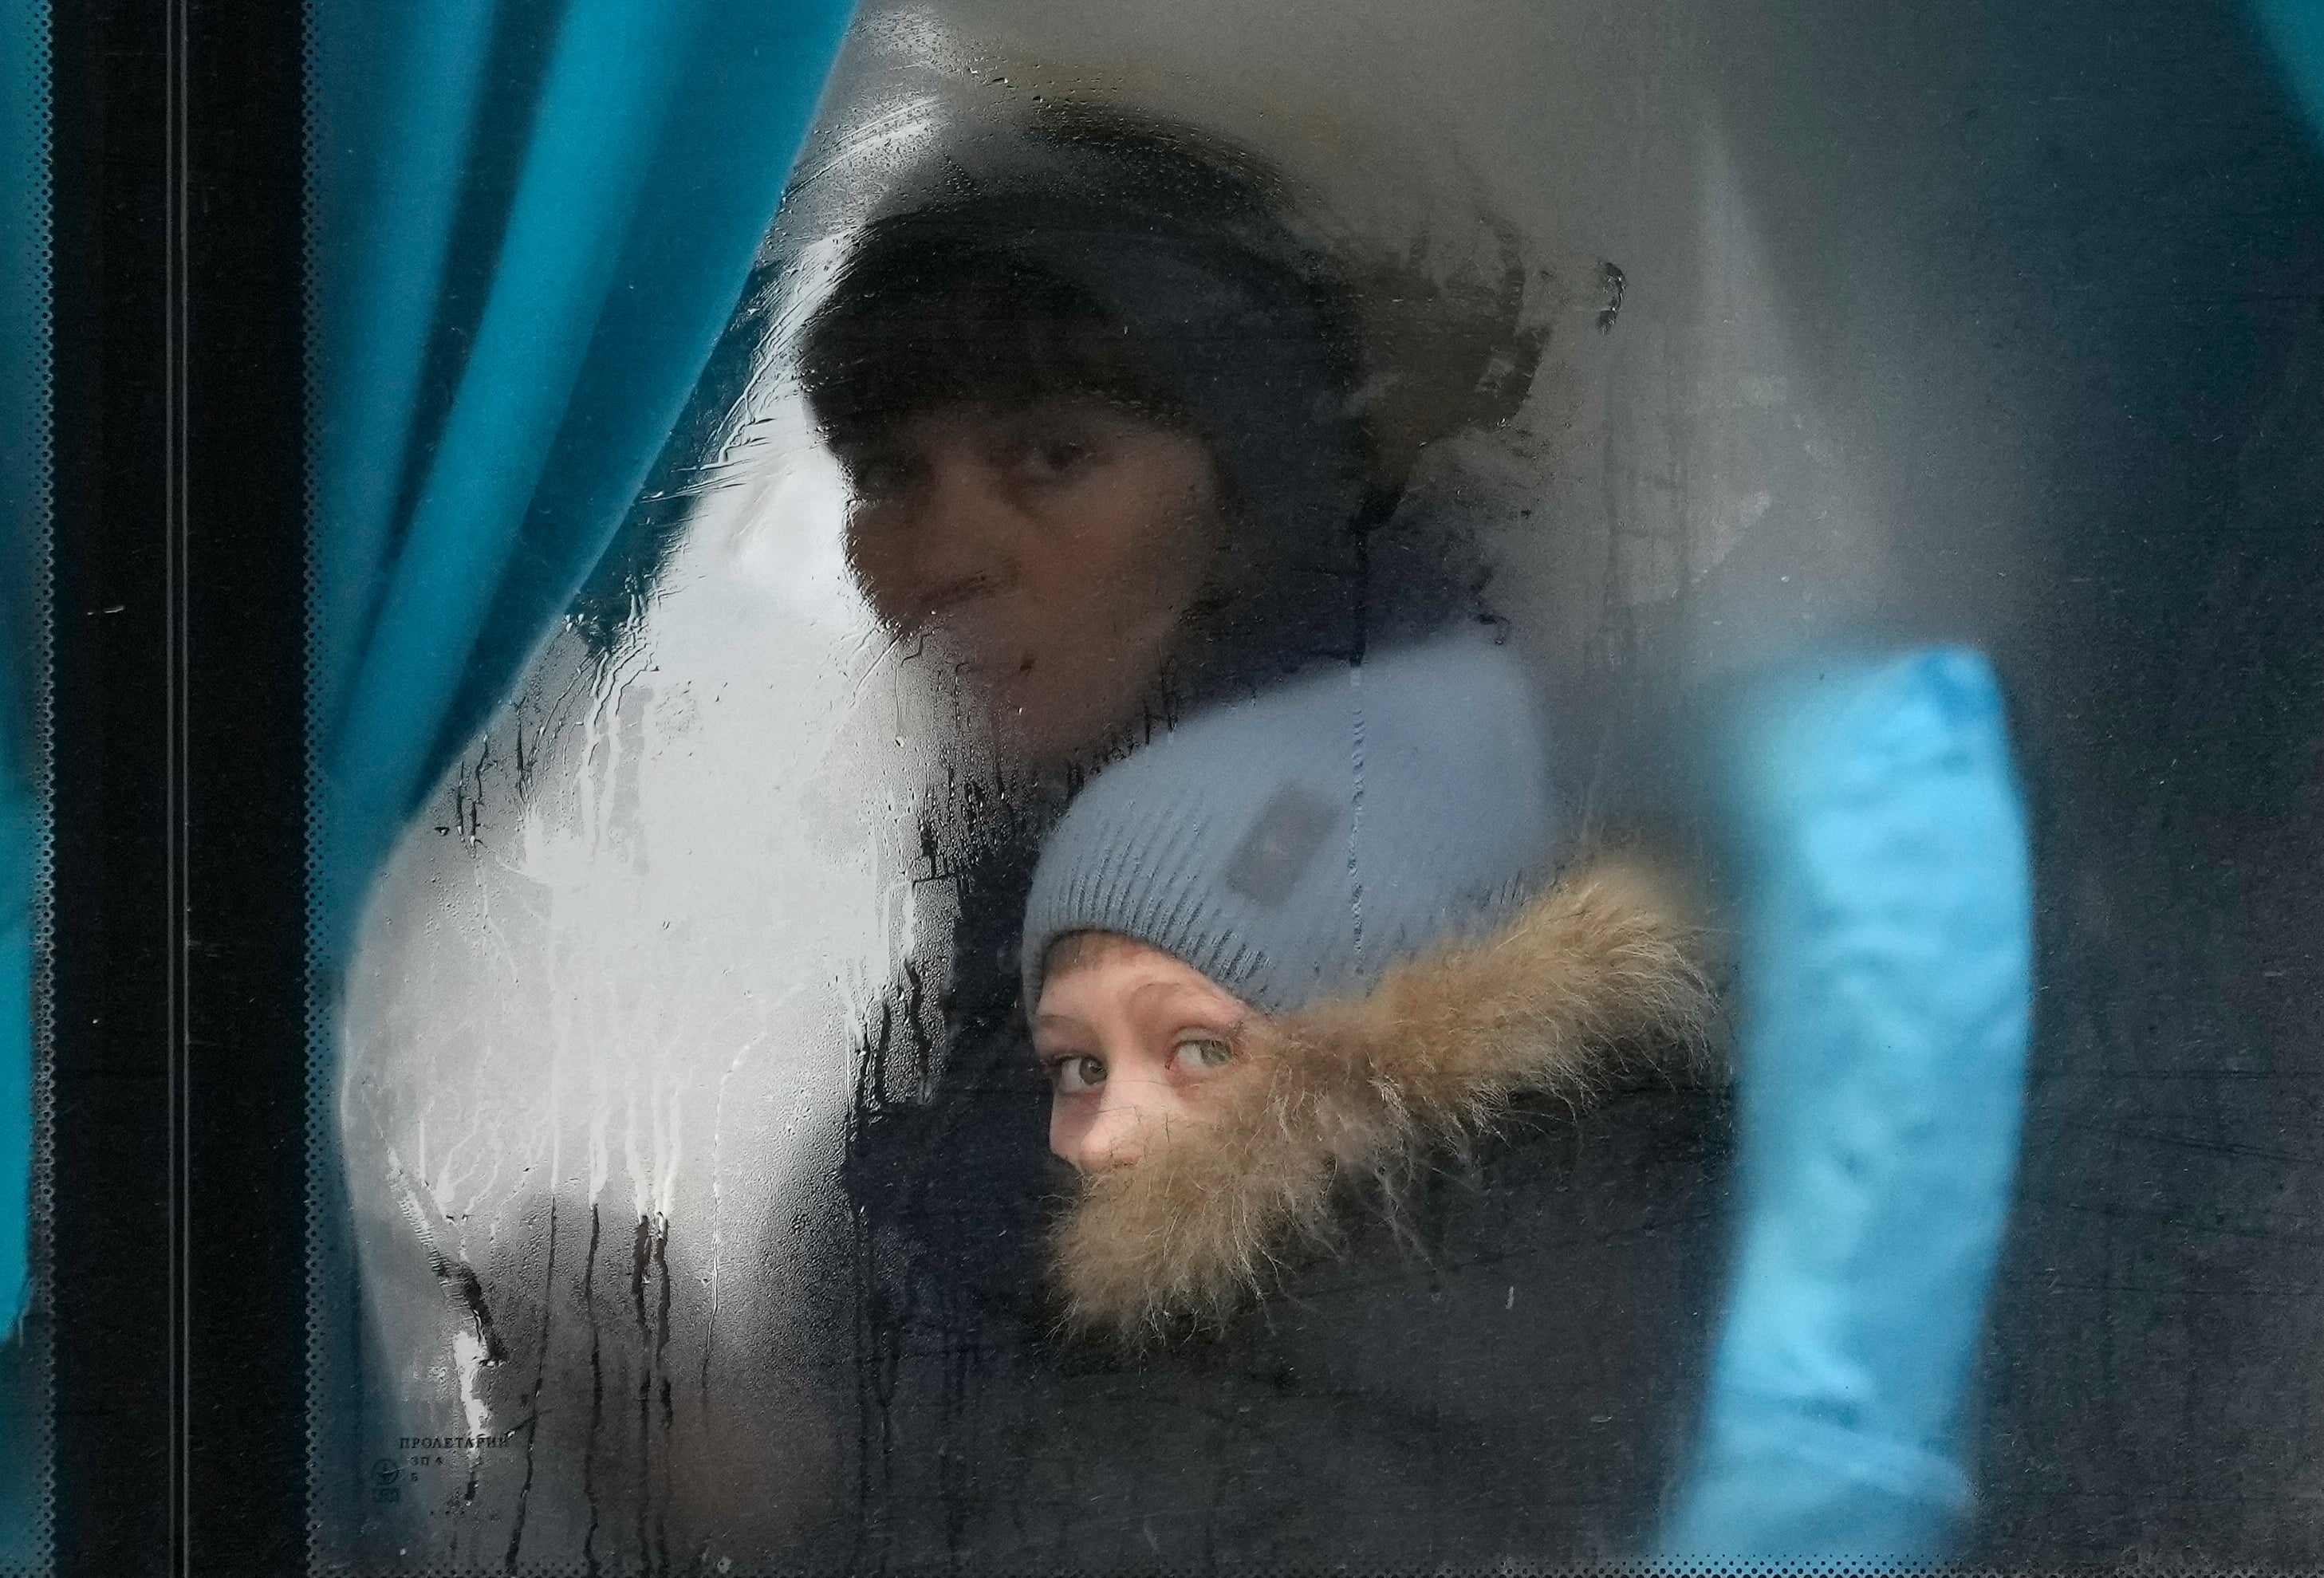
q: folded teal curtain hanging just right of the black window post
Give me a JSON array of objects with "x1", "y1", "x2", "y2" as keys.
[{"x1": 309, "y1": 0, "x2": 849, "y2": 974}]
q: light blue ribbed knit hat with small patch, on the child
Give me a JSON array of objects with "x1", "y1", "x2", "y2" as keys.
[{"x1": 1022, "y1": 630, "x2": 1554, "y2": 1013}]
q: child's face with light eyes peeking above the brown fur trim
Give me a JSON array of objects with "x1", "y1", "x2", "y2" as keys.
[{"x1": 1032, "y1": 932, "x2": 1257, "y2": 1174}]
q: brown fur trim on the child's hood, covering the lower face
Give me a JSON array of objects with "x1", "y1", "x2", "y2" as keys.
[{"x1": 1050, "y1": 857, "x2": 1715, "y2": 1350}]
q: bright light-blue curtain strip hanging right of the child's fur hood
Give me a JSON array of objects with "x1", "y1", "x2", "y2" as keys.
[{"x1": 1662, "y1": 651, "x2": 2031, "y2": 1562}]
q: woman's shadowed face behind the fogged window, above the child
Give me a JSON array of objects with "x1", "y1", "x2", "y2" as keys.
[{"x1": 841, "y1": 399, "x2": 1225, "y2": 760}]
